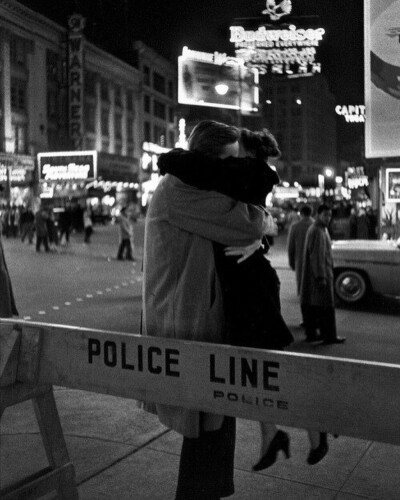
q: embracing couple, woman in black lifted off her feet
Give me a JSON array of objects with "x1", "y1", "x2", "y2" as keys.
[{"x1": 143, "y1": 121, "x2": 327, "y2": 500}]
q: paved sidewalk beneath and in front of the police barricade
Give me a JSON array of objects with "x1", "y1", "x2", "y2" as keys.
[{"x1": 0, "y1": 229, "x2": 400, "y2": 500}]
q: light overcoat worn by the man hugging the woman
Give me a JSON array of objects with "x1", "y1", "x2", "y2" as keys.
[{"x1": 142, "y1": 174, "x2": 266, "y2": 437}]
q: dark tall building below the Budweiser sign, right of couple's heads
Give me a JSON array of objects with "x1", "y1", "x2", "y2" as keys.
[{"x1": 262, "y1": 75, "x2": 338, "y2": 187}]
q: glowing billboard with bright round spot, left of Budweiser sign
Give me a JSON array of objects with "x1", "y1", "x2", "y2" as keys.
[{"x1": 178, "y1": 47, "x2": 259, "y2": 114}]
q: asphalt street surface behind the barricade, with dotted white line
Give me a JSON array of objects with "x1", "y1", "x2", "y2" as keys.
[{"x1": 3, "y1": 220, "x2": 400, "y2": 364}]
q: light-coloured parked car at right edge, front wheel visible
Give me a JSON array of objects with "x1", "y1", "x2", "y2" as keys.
[{"x1": 332, "y1": 238, "x2": 400, "y2": 304}]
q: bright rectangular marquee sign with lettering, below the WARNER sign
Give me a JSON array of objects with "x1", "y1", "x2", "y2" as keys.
[{"x1": 38, "y1": 151, "x2": 97, "y2": 182}]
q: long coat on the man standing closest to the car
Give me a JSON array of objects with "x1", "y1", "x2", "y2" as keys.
[{"x1": 300, "y1": 219, "x2": 334, "y2": 307}]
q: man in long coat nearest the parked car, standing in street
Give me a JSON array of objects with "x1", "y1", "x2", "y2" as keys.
[{"x1": 300, "y1": 205, "x2": 346, "y2": 344}]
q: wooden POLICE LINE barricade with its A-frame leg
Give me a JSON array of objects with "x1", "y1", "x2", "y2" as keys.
[{"x1": 0, "y1": 320, "x2": 400, "y2": 499}]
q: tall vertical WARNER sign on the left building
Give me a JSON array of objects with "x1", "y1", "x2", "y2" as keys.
[{"x1": 68, "y1": 14, "x2": 85, "y2": 149}]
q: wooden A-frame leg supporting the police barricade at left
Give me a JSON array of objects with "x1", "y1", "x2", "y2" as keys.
[{"x1": 0, "y1": 384, "x2": 79, "y2": 500}]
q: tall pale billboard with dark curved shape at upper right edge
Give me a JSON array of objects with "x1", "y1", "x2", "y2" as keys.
[{"x1": 364, "y1": 0, "x2": 400, "y2": 158}]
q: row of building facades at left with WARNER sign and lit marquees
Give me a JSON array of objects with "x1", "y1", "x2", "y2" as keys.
[{"x1": 0, "y1": 0, "x2": 176, "y2": 213}]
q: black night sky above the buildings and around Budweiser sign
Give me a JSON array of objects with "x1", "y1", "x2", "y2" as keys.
[{"x1": 20, "y1": 0, "x2": 364, "y2": 104}]
